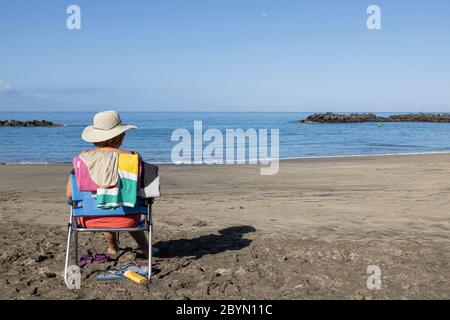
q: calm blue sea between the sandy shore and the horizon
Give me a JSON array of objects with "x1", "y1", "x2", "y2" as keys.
[{"x1": 0, "y1": 112, "x2": 450, "y2": 164}]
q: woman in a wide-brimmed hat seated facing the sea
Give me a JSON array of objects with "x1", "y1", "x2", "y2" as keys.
[{"x1": 66, "y1": 111, "x2": 148, "y2": 256}]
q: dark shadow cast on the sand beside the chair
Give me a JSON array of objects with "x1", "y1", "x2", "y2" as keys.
[{"x1": 155, "y1": 226, "x2": 256, "y2": 259}]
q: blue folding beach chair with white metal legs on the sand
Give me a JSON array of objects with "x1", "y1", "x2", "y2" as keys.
[{"x1": 64, "y1": 174, "x2": 159, "y2": 286}]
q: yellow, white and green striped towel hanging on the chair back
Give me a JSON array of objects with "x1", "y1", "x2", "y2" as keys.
[{"x1": 96, "y1": 154, "x2": 139, "y2": 209}]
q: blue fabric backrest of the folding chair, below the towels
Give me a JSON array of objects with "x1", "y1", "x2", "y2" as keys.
[{"x1": 70, "y1": 174, "x2": 148, "y2": 217}]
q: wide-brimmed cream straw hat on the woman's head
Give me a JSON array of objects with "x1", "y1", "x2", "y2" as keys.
[{"x1": 81, "y1": 111, "x2": 137, "y2": 142}]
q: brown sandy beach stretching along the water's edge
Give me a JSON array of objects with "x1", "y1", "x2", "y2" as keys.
[{"x1": 0, "y1": 154, "x2": 450, "y2": 299}]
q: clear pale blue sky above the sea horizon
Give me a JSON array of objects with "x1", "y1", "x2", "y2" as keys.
[{"x1": 0, "y1": 0, "x2": 450, "y2": 112}]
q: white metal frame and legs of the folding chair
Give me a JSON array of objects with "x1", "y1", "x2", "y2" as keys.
[{"x1": 64, "y1": 175, "x2": 154, "y2": 286}]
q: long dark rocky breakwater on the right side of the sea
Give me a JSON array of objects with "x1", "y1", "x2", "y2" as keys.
[{"x1": 296, "y1": 112, "x2": 450, "y2": 124}]
